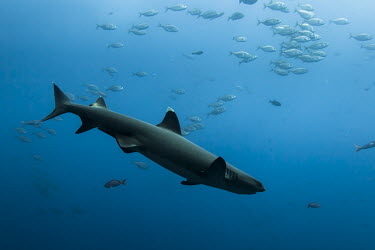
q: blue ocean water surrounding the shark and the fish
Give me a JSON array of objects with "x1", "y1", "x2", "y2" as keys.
[{"x1": 0, "y1": 0, "x2": 375, "y2": 250}]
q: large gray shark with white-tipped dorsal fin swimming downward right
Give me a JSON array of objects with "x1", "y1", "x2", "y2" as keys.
[{"x1": 42, "y1": 85, "x2": 265, "y2": 194}]
